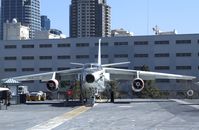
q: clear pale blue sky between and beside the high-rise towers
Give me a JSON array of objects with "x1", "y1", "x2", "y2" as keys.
[{"x1": 40, "y1": 0, "x2": 199, "y2": 36}]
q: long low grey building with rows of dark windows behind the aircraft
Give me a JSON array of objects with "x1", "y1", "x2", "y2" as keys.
[{"x1": 0, "y1": 34, "x2": 199, "y2": 97}]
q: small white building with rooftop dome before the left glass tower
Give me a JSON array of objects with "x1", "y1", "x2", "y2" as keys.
[{"x1": 3, "y1": 19, "x2": 30, "y2": 40}]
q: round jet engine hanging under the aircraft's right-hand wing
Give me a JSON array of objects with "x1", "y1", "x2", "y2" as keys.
[{"x1": 132, "y1": 78, "x2": 144, "y2": 92}]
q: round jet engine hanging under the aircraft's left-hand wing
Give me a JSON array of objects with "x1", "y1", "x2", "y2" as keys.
[{"x1": 46, "y1": 79, "x2": 59, "y2": 92}]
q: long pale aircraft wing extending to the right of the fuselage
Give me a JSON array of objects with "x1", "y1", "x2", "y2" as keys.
[{"x1": 104, "y1": 68, "x2": 196, "y2": 80}]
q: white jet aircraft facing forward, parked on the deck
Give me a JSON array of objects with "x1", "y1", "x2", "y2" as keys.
[{"x1": 0, "y1": 39, "x2": 196, "y2": 105}]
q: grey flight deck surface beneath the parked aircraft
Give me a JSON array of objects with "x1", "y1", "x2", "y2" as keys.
[{"x1": 0, "y1": 99, "x2": 199, "y2": 130}]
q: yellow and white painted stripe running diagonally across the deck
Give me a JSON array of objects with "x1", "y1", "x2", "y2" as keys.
[{"x1": 27, "y1": 106, "x2": 91, "y2": 130}]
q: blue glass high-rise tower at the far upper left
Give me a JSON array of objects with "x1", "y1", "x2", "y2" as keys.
[{"x1": 0, "y1": 0, "x2": 41, "y2": 39}]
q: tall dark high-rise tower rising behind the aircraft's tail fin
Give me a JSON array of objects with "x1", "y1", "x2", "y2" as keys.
[{"x1": 70, "y1": 0, "x2": 111, "y2": 37}]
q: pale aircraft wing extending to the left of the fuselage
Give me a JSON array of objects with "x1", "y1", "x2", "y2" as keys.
[{"x1": 2, "y1": 68, "x2": 82, "y2": 81}]
